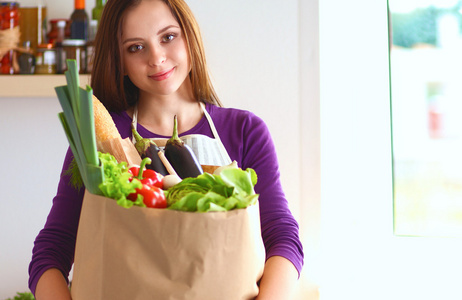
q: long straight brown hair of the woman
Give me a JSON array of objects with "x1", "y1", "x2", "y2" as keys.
[{"x1": 91, "y1": 0, "x2": 222, "y2": 111}]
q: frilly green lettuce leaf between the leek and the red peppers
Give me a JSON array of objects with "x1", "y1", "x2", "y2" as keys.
[{"x1": 98, "y1": 152, "x2": 146, "y2": 208}]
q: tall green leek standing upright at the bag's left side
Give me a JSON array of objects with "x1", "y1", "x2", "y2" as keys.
[{"x1": 55, "y1": 59, "x2": 103, "y2": 195}]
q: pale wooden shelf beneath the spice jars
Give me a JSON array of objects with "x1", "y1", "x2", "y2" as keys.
[{"x1": 0, "y1": 74, "x2": 90, "y2": 98}]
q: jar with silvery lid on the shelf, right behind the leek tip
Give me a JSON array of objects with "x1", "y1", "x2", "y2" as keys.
[{"x1": 59, "y1": 39, "x2": 87, "y2": 74}]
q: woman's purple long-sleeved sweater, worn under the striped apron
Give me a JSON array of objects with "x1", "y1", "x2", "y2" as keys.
[{"x1": 29, "y1": 104, "x2": 303, "y2": 294}]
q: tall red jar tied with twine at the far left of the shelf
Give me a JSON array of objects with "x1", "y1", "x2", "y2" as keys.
[{"x1": 0, "y1": 2, "x2": 20, "y2": 74}]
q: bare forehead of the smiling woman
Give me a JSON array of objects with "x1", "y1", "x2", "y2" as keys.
[{"x1": 122, "y1": 0, "x2": 179, "y2": 35}]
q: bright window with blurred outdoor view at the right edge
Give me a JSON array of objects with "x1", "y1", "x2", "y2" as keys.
[{"x1": 389, "y1": 0, "x2": 462, "y2": 237}]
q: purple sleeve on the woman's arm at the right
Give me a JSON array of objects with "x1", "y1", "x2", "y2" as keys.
[{"x1": 211, "y1": 107, "x2": 304, "y2": 274}]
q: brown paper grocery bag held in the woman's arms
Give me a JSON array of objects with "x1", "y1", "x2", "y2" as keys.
[{"x1": 71, "y1": 191, "x2": 265, "y2": 300}]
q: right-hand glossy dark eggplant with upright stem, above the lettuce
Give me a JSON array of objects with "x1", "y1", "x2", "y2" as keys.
[{"x1": 164, "y1": 115, "x2": 204, "y2": 179}]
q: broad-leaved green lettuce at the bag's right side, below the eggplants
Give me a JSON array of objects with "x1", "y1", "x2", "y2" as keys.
[{"x1": 165, "y1": 168, "x2": 258, "y2": 212}]
